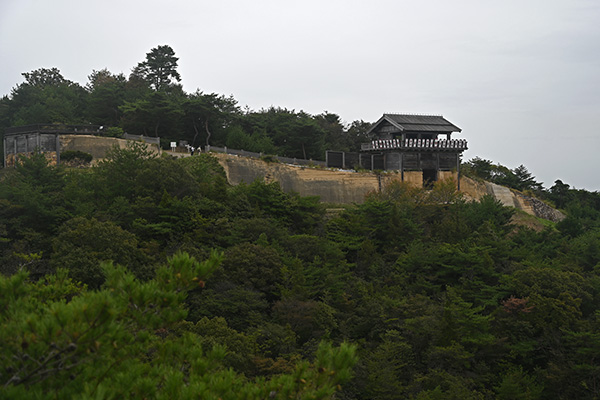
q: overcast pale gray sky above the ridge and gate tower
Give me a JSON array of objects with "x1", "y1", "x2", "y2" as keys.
[{"x1": 0, "y1": 0, "x2": 600, "y2": 191}]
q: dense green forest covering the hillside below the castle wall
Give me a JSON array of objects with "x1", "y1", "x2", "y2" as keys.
[{"x1": 0, "y1": 144, "x2": 600, "y2": 400}]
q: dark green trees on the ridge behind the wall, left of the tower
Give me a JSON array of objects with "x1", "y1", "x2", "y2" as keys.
[{"x1": 0, "y1": 45, "x2": 369, "y2": 160}]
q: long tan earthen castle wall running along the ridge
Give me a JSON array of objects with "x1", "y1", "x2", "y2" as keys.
[{"x1": 6, "y1": 130, "x2": 564, "y2": 221}]
